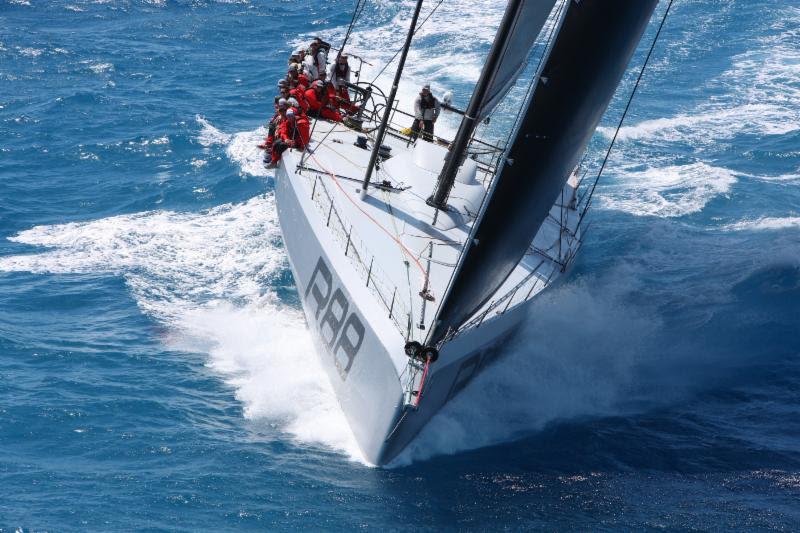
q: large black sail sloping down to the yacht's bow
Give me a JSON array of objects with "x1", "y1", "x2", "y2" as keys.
[{"x1": 428, "y1": 0, "x2": 658, "y2": 345}]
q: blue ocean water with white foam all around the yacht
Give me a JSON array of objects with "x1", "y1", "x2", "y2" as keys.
[{"x1": 0, "y1": 0, "x2": 800, "y2": 531}]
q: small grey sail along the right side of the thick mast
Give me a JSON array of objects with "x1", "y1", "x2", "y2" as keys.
[{"x1": 477, "y1": 0, "x2": 556, "y2": 122}]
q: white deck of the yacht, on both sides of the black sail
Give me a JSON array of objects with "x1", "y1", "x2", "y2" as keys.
[{"x1": 283, "y1": 120, "x2": 578, "y2": 342}]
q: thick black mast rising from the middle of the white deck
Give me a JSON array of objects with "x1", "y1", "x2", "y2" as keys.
[{"x1": 428, "y1": 0, "x2": 523, "y2": 209}]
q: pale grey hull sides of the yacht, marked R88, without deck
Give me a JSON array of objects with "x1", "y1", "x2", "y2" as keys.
[{"x1": 276, "y1": 156, "x2": 526, "y2": 465}]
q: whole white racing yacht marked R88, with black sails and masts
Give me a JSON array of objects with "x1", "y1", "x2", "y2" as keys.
[{"x1": 275, "y1": 0, "x2": 657, "y2": 465}]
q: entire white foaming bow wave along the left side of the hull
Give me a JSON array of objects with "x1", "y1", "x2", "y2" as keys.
[{"x1": 0, "y1": 195, "x2": 362, "y2": 460}]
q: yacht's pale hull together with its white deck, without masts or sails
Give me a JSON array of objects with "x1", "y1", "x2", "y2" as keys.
[{"x1": 275, "y1": 123, "x2": 577, "y2": 465}]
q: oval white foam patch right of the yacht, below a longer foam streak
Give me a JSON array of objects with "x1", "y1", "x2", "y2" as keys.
[{"x1": 598, "y1": 163, "x2": 736, "y2": 217}]
